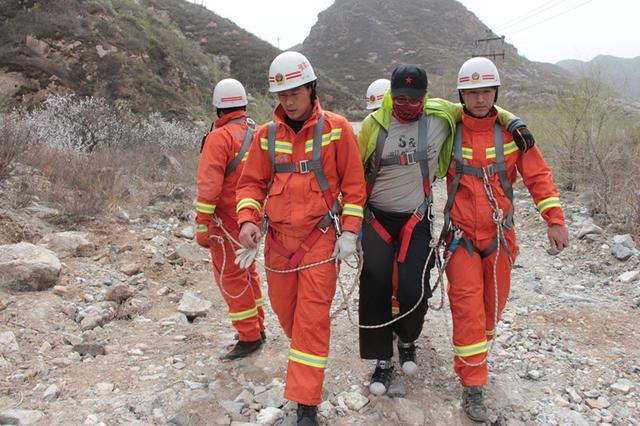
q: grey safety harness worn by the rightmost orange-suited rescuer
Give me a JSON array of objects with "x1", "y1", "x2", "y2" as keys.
[{"x1": 441, "y1": 123, "x2": 514, "y2": 258}]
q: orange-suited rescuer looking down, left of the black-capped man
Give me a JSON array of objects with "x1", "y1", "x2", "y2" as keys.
[{"x1": 236, "y1": 52, "x2": 366, "y2": 425}]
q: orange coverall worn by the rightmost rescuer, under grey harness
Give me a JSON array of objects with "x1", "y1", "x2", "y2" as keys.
[{"x1": 446, "y1": 113, "x2": 565, "y2": 386}]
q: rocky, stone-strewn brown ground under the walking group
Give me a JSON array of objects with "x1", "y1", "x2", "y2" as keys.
[{"x1": 0, "y1": 166, "x2": 640, "y2": 426}]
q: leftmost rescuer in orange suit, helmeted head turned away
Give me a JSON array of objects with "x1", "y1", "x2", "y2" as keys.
[{"x1": 196, "y1": 78, "x2": 265, "y2": 359}]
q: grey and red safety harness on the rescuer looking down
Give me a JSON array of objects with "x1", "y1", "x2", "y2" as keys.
[{"x1": 267, "y1": 112, "x2": 341, "y2": 268}]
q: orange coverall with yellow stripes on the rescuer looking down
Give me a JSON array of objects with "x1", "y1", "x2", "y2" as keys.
[{"x1": 236, "y1": 100, "x2": 366, "y2": 405}]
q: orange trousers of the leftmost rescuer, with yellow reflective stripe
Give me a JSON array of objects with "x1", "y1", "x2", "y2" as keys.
[{"x1": 211, "y1": 230, "x2": 263, "y2": 342}]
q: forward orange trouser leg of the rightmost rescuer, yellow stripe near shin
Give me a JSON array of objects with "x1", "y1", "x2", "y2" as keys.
[{"x1": 446, "y1": 238, "x2": 487, "y2": 386}]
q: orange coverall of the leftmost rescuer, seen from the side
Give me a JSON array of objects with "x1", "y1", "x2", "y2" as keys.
[{"x1": 196, "y1": 111, "x2": 264, "y2": 342}]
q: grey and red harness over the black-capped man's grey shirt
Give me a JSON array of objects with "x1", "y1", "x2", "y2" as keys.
[{"x1": 365, "y1": 114, "x2": 433, "y2": 263}]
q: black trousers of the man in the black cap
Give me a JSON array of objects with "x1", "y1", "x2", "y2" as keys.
[{"x1": 358, "y1": 209, "x2": 435, "y2": 359}]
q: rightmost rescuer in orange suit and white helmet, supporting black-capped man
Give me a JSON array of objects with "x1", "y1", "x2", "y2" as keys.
[{"x1": 444, "y1": 58, "x2": 569, "y2": 422}]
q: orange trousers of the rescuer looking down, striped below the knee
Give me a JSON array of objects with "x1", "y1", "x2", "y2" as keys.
[{"x1": 265, "y1": 228, "x2": 336, "y2": 405}]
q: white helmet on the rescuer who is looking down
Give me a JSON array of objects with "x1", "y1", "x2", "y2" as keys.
[{"x1": 269, "y1": 52, "x2": 318, "y2": 93}]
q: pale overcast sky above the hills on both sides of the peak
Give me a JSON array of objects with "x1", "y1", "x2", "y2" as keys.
[{"x1": 202, "y1": 0, "x2": 640, "y2": 62}]
